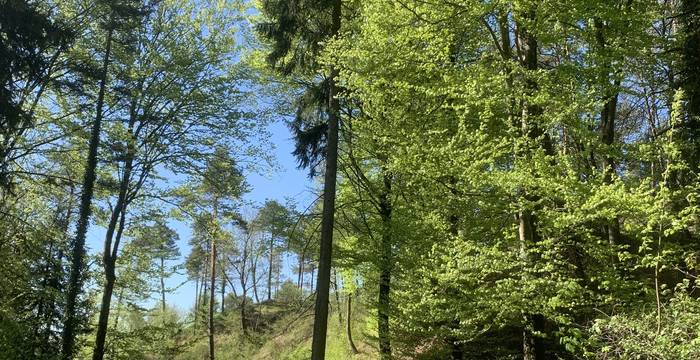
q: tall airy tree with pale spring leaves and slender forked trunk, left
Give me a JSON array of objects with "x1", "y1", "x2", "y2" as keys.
[{"x1": 87, "y1": 2, "x2": 251, "y2": 359}]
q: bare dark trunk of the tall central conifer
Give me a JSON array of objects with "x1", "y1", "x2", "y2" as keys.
[{"x1": 311, "y1": 0, "x2": 342, "y2": 360}]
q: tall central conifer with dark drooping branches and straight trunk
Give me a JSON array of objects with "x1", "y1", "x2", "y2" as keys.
[{"x1": 257, "y1": 0, "x2": 342, "y2": 360}]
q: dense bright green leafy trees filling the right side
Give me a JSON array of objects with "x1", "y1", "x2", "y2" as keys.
[{"x1": 260, "y1": 0, "x2": 699, "y2": 359}]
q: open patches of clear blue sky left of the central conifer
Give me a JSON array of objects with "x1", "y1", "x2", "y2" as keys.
[{"x1": 88, "y1": 120, "x2": 314, "y2": 311}]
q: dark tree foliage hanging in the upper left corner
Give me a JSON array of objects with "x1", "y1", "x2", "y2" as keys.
[{"x1": 0, "y1": 0, "x2": 76, "y2": 193}]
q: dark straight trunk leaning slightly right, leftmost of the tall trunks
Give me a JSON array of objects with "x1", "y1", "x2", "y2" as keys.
[{"x1": 61, "y1": 27, "x2": 114, "y2": 360}]
